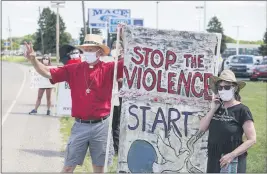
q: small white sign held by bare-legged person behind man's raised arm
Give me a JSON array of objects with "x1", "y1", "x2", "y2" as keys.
[{"x1": 29, "y1": 67, "x2": 55, "y2": 88}]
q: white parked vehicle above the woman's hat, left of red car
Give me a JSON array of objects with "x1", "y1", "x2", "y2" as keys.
[{"x1": 223, "y1": 55, "x2": 262, "y2": 77}]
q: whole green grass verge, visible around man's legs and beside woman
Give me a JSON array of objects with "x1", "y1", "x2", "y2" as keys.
[{"x1": 61, "y1": 82, "x2": 267, "y2": 173}]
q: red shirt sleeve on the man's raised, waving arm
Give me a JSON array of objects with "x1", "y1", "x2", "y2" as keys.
[{"x1": 50, "y1": 66, "x2": 69, "y2": 84}]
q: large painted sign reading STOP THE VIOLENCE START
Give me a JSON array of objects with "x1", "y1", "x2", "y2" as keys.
[{"x1": 118, "y1": 26, "x2": 221, "y2": 173}]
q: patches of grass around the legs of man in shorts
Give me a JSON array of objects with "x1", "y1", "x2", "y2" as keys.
[{"x1": 60, "y1": 117, "x2": 118, "y2": 173}]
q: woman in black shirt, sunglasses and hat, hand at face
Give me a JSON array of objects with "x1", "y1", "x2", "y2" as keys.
[{"x1": 200, "y1": 70, "x2": 256, "y2": 173}]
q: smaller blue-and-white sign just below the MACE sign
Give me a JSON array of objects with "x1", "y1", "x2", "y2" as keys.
[{"x1": 109, "y1": 18, "x2": 144, "y2": 33}]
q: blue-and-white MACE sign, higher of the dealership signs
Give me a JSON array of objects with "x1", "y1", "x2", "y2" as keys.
[{"x1": 88, "y1": 8, "x2": 131, "y2": 28}]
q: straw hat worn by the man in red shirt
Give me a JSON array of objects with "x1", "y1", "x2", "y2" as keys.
[{"x1": 77, "y1": 34, "x2": 110, "y2": 55}]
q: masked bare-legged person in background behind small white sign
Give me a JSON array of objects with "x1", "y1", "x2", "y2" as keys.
[{"x1": 29, "y1": 54, "x2": 52, "y2": 115}]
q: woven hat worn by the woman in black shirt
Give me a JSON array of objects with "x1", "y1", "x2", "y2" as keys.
[{"x1": 209, "y1": 70, "x2": 246, "y2": 94}]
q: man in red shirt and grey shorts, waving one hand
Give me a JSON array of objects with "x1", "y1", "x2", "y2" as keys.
[{"x1": 25, "y1": 34, "x2": 123, "y2": 173}]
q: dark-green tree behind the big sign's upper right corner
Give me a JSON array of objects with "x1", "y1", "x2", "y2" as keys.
[{"x1": 207, "y1": 16, "x2": 226, "y2": 54}]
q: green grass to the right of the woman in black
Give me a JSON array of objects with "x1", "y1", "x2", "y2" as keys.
[{"x1": 241, "y1": 82, "x2": 267, "y2": 173}]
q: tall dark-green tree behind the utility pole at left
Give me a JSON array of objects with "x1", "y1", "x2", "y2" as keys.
[{"x1": 34, "y1": 8, "x2": 71, "y2": 54}]
